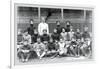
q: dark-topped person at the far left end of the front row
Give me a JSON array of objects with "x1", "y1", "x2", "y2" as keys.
[{"x1": 18, "y1": 40, "x2": 31, "y2": 62}]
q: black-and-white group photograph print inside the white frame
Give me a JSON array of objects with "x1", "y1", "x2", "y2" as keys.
[{"x1": 15, "y1": 5, "x2": 93, "y2": 63}]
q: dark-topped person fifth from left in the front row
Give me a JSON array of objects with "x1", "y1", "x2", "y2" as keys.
[{"x1": 69, "y1": 37, "x2": 77, "y2": 56}]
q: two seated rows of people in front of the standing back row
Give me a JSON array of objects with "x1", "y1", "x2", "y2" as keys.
[{"x1": 17, "y1": 22, "x2": 92, "y2": 62}]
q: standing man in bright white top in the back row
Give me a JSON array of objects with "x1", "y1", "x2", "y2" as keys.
[{"x1": 38, "y1": 17, "x2": 49, "y2": 35}]
